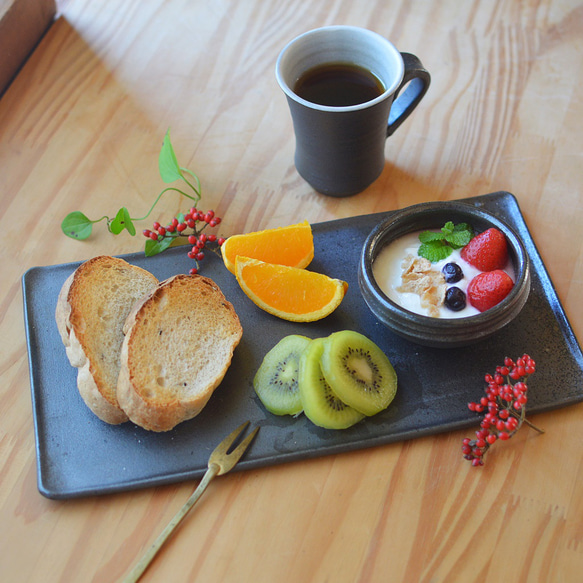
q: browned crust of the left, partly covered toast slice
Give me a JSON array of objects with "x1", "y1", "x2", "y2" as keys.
[{"x1": 55, "y1": 256, "x2": 158, "y2": 425}]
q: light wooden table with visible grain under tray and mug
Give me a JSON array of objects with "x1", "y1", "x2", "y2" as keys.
[{"x1": 0, "y1": 0, "x2": 583, "y2": 583}]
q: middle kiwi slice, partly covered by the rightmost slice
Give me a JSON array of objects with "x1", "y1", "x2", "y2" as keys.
[{"x1": 299, "y1": 338, "x2": 364, "y2": 429}]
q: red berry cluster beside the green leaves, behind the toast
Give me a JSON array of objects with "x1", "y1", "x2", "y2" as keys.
[{"x1": 143, "y1": 207, "x2": 225, "y2": 275}]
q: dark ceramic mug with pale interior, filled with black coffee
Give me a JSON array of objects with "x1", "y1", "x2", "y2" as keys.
[{"x1": 275, "y1": 26, "x2": 431, "y2": 197}]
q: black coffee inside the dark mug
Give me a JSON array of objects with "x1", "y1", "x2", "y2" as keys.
[{"x1": 293, "y1": 63, "x2": 385, "y2": 107}]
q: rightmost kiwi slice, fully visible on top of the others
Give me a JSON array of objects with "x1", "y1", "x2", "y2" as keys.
[{"x1": 320, "y1": 330, "x2": 397, "y2": 416}]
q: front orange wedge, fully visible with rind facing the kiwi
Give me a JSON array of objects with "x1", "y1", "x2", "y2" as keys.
[{"x1": 235, "y1": 256, "x2": 348, "y2": 322}]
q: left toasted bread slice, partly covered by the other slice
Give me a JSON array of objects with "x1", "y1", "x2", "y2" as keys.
[{"x1": 55, "y1": 256, "x2": 158, "y2": 425}]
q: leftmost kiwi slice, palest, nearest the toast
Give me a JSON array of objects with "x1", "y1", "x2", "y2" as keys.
[{"x1": 253, "y1": 334, "x2": 311, "y2": 415}]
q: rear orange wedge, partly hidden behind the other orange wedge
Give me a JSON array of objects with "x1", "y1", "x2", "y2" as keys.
[{"x1": 221, "y1": 221, "x2": 314, "y2": 273}]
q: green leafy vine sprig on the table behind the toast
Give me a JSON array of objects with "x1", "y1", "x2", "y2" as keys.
[{"x1": 61, "y1": 130, "x2": 201, "y2": 241}]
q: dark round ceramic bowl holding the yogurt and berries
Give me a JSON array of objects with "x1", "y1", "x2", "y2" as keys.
[{"x1": 358, "y1": 202, "x2": 530, "y2": 348}]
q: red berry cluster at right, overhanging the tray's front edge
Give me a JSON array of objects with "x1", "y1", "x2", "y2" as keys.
[{"x1": 462, "y1": 354, "x2": 543, "y2": 466}]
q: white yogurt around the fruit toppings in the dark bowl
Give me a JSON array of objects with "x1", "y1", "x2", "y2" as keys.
[{"x1": 372, "y1": 231, "x2": 516, "y2": 318}]
